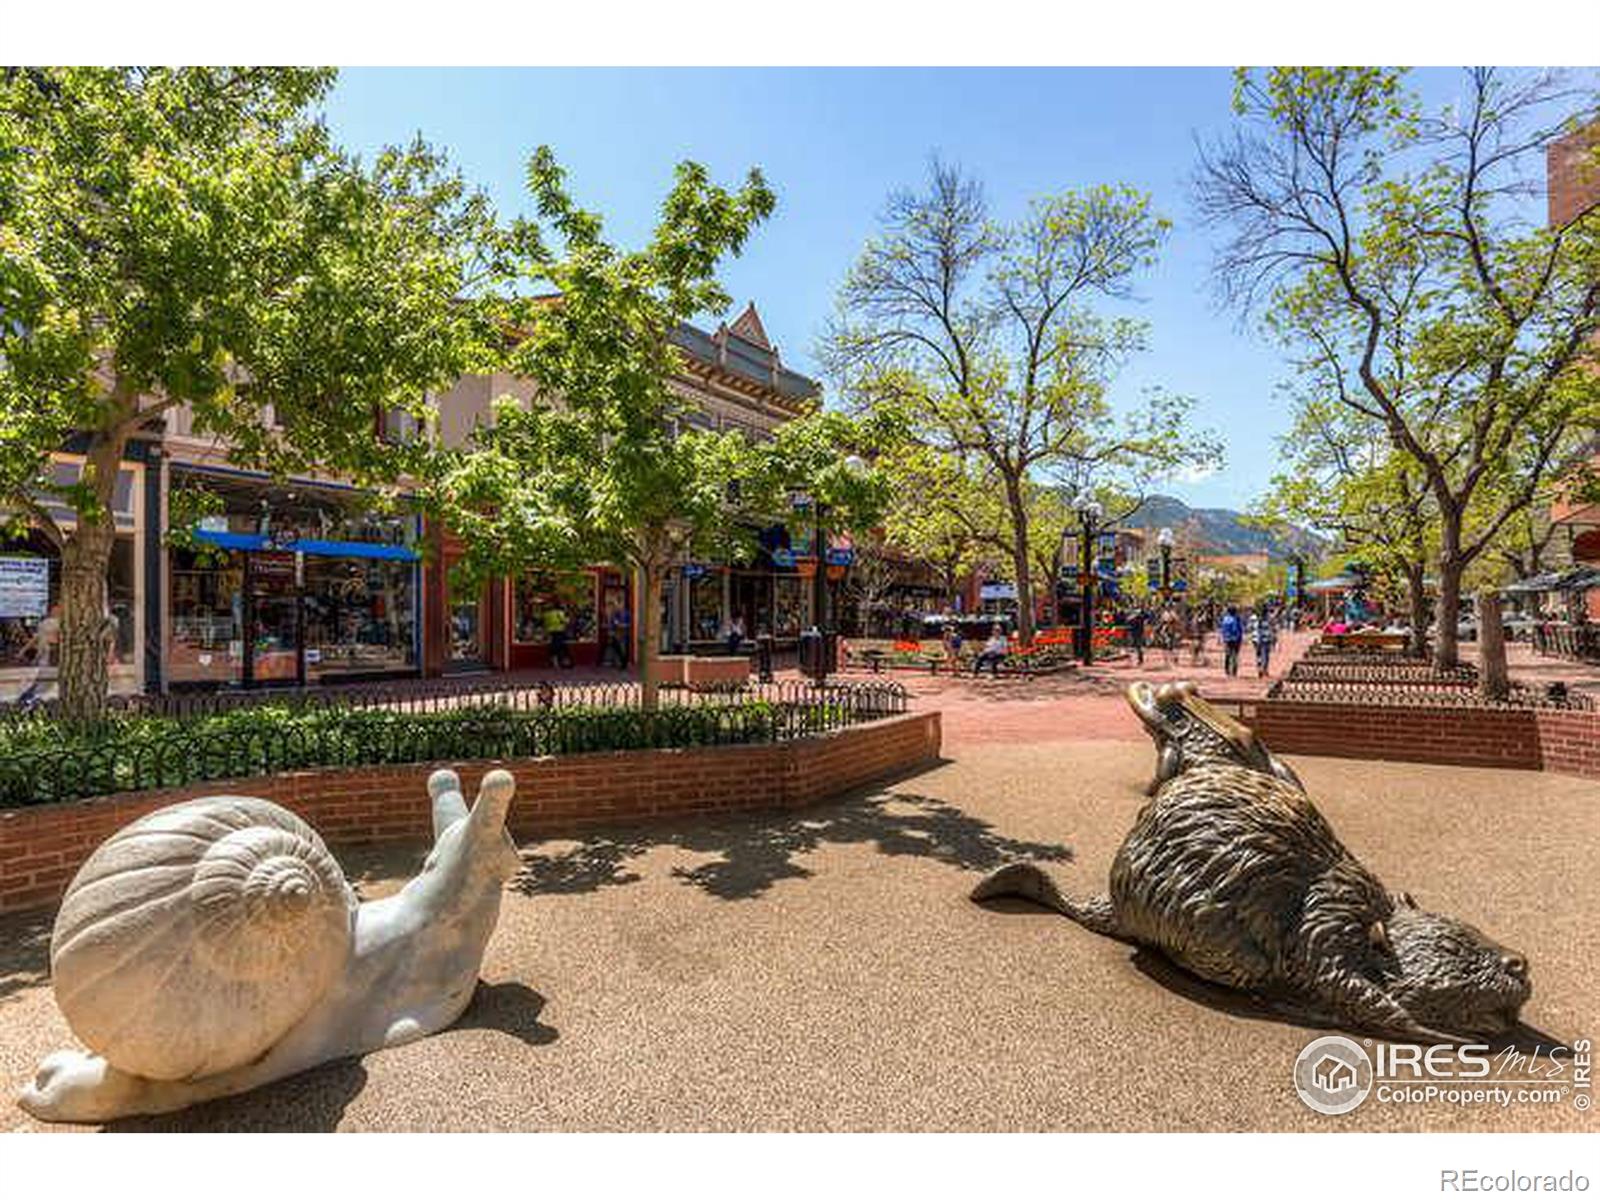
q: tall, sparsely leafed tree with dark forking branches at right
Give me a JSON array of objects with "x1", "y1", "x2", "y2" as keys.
[{"x1": 1197, "y1": 67, "x2": 1600, "y2": 666}]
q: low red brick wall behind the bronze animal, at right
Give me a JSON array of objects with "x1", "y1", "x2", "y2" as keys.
[{"x1": 1242, "y1": 699, "x2": 1600, "y2": 779}]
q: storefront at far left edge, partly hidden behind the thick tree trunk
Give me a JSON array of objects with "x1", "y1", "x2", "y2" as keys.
[{"x1": 0, "y1": 445, "x2": 150, "y2": 702}]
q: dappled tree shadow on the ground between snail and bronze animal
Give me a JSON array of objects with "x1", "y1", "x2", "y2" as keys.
[{"x1": 512, "y1": 790, "x2": 1072, "y2": 901}]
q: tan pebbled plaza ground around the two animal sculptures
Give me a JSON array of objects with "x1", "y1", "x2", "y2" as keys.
[{"x1": 0, "y1": 729, "x2": 1600, "y2": 1131}]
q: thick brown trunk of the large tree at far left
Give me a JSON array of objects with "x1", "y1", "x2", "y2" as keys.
[{"x1": 58, "y1": 510, "x2": 117, "y2": 722}]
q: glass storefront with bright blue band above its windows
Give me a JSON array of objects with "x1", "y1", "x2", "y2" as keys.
[{"x1": 166, "y1": 470, "x2": 421, "y2": 688}]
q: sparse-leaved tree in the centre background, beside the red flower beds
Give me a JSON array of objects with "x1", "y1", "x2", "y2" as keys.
[{"x1": 822, "y1": 162, "x2": 1218, "y2": 642}]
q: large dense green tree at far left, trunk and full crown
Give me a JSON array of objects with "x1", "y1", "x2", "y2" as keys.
[{"x1": 0, "y1": 69, "x2": 491, "y2": 718}]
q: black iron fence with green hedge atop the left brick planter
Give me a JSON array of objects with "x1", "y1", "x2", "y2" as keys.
[{"x1": 0, "y1": 682, "x2": 907, "y2": 808}]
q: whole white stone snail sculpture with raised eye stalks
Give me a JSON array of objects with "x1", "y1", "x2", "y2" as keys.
[{"x1": 19, "y1": 771, "x2": 520, "y2": 1122}]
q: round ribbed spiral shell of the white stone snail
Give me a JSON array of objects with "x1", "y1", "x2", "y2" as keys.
[{"x1": 50, "y1": 795, "x2": 355, "y2": 1080}]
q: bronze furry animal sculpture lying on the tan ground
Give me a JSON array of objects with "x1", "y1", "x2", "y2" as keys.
[{"x1": 973, "y1": 683, "x2": 1531, "y2": 1042}]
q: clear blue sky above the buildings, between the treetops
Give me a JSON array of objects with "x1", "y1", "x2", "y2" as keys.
[{"x1": 328, "y1": 67, "x2": 1454, "y2": 507}]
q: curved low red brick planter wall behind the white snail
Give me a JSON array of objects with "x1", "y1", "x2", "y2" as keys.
[{"x1": 0, "y1": 712, "x2": 941, "y2": 912}]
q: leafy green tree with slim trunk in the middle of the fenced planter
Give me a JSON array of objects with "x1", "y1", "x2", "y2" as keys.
[{"x1": 429, "y1": 155, "x2": 883, "y2": 707}]
